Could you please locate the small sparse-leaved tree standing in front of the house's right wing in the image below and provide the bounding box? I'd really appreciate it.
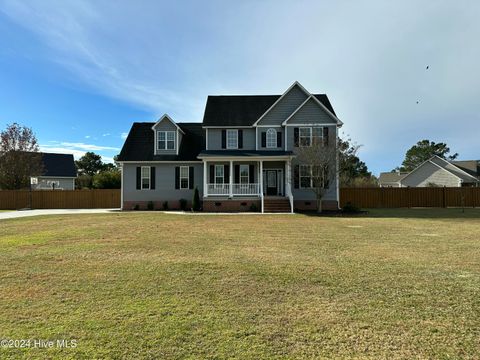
[294,128,338,212]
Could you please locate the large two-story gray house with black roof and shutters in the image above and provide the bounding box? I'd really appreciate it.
[118,82,342,211]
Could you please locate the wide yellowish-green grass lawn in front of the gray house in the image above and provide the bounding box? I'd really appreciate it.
[0,210,480,359]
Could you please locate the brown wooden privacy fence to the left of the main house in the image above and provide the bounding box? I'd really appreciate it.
[0,189,120,210]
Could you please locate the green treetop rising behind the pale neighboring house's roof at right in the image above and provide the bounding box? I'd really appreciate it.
[397,140,458,172]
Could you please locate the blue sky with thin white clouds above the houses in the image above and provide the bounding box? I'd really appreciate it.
[0,0,480,174]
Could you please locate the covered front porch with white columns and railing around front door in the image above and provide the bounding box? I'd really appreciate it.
[197,151,293,212]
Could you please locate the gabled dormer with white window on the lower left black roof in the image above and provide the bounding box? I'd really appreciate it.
[152,114,185,155]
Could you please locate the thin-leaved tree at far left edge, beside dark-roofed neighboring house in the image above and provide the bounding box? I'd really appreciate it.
[0,123,43,190]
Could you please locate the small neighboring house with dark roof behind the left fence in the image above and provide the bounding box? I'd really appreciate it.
[32,153,77,190]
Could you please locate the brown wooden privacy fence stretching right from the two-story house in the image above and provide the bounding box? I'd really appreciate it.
[340,187,480,208]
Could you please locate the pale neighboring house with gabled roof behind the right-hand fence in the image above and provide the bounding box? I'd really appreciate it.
[379,156,480,187]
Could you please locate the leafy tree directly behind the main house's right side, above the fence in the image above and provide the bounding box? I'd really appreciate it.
[338,138,376,186]
